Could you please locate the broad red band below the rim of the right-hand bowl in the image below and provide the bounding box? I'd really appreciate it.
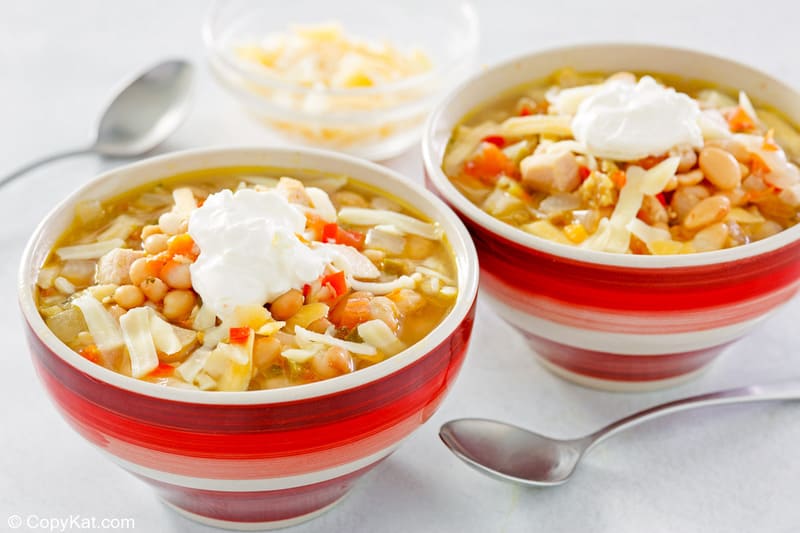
[462,215,800,312]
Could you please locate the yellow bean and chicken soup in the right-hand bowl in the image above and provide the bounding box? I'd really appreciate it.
[442,69,800,254]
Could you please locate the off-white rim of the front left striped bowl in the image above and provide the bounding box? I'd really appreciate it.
[17,146,479,405]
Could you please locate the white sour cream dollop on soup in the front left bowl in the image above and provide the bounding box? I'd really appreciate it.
[189,189,328,319]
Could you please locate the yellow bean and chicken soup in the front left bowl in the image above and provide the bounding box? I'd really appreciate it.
[37,167,456,390]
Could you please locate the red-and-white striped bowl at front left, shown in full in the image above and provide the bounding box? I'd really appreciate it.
[19,148,478,529]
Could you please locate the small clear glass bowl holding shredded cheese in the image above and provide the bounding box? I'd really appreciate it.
[203,0,478,160]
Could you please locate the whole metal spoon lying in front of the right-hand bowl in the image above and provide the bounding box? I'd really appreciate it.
[439,380,800,487]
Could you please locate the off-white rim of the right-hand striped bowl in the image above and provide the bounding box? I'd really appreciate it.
[422,41,800,270]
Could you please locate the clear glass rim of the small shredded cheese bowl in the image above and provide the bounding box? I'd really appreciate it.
[202,0,480,97]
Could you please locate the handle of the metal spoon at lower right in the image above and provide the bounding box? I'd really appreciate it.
[586,379,800,451]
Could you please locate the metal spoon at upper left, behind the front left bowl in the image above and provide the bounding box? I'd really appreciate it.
[0,60,193,187]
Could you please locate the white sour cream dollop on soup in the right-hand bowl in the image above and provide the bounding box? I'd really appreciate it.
[572,76,703,161]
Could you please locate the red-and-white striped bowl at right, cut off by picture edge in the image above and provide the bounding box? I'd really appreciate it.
[423,44,800,390]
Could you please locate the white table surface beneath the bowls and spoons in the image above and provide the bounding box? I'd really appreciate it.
[0,0,800,533]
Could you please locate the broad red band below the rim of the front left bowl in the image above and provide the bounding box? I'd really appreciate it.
[28,303,475,479]
